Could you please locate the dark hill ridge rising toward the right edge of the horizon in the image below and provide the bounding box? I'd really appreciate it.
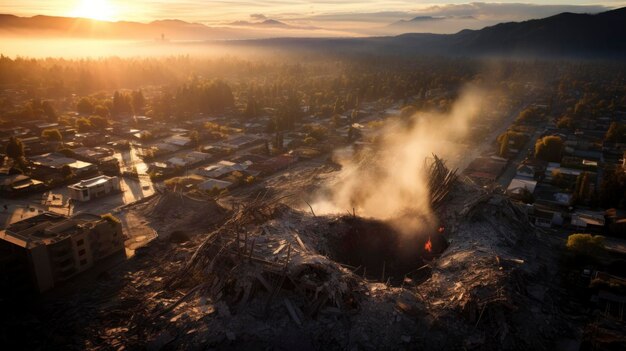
[235,8,626,58]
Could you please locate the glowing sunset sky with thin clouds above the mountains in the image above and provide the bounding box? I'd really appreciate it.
[0,0,626,34]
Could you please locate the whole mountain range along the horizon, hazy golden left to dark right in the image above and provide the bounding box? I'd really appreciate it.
[0,7,626,57]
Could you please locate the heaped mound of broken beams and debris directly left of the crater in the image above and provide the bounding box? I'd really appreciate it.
[168,195,366,338]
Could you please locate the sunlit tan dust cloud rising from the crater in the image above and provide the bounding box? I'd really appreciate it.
[312,86,487,234]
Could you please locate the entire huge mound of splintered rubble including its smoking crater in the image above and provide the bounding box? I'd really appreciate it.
[1,157,596,350]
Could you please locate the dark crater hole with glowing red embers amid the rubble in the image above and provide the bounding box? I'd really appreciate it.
[328,216,448,285]
